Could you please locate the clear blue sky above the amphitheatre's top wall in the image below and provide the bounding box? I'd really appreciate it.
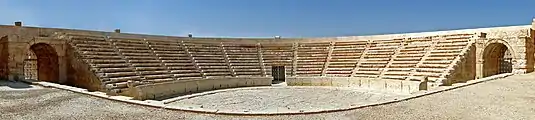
[0,0,535,37]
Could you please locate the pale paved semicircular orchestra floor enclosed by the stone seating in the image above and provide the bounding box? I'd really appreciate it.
[167,86,408,113]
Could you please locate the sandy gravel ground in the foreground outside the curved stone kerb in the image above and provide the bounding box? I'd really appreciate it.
[0,73,535,120]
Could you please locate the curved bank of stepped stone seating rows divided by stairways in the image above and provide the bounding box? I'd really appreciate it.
[65,34,475,99]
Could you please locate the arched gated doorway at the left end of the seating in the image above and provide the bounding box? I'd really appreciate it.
[24,43,59,83]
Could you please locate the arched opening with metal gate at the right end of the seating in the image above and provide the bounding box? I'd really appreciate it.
[483,43,513,77]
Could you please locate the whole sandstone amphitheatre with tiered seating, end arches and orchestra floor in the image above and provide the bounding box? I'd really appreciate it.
[0,19,535,118]
